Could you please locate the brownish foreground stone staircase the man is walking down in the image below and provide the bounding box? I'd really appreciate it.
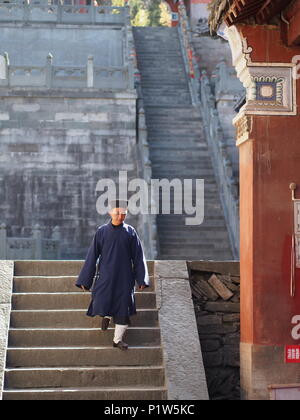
[3,261,167,400]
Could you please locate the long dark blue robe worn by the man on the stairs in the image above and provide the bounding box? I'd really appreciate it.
[76,221,149,323]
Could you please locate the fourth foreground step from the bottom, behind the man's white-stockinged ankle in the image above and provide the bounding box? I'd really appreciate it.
[8,327,160,351]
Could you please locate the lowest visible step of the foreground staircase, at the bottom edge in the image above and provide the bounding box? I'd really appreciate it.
[3,386,167,401]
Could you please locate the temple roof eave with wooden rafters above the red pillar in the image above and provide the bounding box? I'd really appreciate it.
[208,0,292,32]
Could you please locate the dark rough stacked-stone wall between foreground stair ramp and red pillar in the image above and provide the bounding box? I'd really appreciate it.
[188,261,240,400]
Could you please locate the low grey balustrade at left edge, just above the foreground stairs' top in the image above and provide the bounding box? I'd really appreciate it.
[0,223,61,260]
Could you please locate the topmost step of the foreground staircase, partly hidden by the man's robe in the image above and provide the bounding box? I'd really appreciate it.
[14,260,154,276]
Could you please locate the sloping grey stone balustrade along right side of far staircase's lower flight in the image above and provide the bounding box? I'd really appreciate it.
[201,71,240,259]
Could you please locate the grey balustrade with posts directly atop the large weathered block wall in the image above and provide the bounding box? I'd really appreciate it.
[0,53,133,90]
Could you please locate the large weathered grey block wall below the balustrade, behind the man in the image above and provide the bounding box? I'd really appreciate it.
[0,88,138,259]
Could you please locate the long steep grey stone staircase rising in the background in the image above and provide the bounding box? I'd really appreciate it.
[133,27,232,260]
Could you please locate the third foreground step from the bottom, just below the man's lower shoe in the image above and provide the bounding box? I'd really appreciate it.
[7,344,163,367]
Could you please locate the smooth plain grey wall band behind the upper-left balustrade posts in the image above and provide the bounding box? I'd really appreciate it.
[1,23,125,67]
